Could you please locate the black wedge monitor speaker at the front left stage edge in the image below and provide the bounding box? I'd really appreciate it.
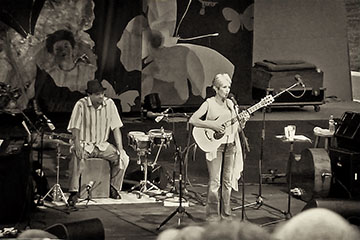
[45,218,105,240]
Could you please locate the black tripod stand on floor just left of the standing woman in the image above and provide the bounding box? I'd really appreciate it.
[156,136,194,230]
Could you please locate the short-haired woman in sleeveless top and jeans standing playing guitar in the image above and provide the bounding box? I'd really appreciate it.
[189,73,250,221]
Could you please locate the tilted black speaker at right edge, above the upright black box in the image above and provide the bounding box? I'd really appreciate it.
[334,112,360,151]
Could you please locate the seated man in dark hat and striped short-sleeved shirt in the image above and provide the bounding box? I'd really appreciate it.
[68,80,129,206]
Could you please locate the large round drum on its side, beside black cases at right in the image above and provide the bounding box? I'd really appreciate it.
[290,148,332,201]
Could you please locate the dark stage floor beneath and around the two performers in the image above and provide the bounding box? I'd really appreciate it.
[2,101,360,239]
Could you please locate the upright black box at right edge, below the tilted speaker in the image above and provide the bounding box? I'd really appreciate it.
[329,148,360,199]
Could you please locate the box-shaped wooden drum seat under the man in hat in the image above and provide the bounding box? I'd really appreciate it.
[80,158,110,198]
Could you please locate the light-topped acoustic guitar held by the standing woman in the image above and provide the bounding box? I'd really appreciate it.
[192,95,274,152]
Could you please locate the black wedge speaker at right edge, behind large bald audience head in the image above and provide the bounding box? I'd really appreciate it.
[301,198,360,225]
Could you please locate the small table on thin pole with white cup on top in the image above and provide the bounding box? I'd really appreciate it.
[276,135,311,217]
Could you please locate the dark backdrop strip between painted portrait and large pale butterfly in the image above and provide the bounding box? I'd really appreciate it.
[88,0,142,99]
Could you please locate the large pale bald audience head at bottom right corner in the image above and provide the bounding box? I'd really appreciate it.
[272,208,360,240]
